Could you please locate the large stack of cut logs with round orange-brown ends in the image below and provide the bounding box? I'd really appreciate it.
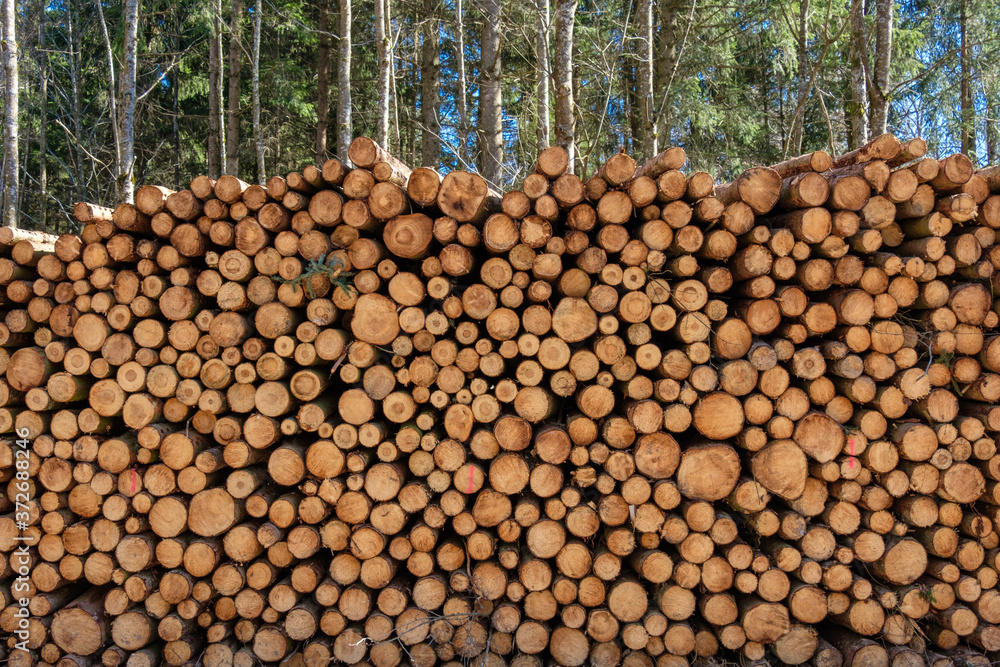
[0,135,1000,667]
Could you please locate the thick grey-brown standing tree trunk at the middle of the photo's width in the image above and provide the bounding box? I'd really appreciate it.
[478,0,503,187]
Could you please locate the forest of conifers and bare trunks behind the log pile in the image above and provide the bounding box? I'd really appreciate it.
[0,0,1000,232]
